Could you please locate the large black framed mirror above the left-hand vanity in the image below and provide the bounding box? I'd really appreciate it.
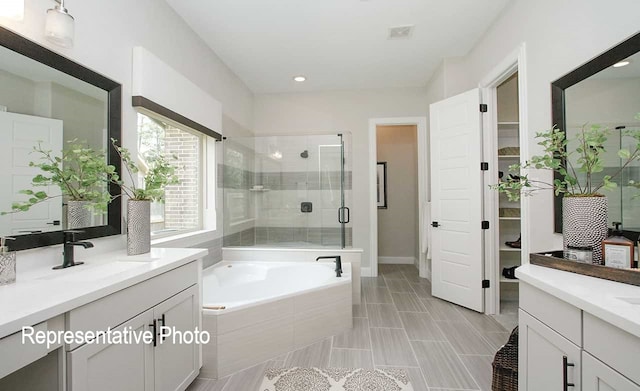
[0,27,122,250]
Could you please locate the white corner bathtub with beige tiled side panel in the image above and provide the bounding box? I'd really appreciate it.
[200,261,353,379]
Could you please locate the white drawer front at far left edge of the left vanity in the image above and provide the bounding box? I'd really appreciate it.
[0,315,64,379]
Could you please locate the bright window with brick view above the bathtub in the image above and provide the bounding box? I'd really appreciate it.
[138,113,215,235]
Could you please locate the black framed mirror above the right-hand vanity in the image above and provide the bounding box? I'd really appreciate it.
[551,33,640,233]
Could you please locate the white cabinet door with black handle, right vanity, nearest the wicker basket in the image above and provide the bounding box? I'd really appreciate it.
[518,310,580,391]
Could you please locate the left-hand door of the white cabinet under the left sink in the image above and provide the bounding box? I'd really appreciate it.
[67,310,154,391]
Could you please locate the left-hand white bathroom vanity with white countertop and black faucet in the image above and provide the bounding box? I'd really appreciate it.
[0,249,207,391]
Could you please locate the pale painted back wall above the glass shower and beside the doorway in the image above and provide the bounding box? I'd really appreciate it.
[254,88,428,268]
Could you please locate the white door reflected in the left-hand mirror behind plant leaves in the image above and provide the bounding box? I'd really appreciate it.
[0,112,62,236]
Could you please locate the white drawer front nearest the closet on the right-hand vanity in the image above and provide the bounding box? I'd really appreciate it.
[520,283,582,346]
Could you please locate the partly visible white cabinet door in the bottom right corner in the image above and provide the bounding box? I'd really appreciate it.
[582,352,640,391]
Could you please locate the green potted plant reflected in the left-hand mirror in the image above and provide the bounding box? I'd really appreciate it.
[3,139,118,228]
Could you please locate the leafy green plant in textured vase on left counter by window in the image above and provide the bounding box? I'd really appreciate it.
[111,139,179,255]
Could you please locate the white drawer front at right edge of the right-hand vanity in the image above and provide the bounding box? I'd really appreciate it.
[584,312,640,384]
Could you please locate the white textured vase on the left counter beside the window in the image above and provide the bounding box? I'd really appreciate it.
[127,200,151,255]
